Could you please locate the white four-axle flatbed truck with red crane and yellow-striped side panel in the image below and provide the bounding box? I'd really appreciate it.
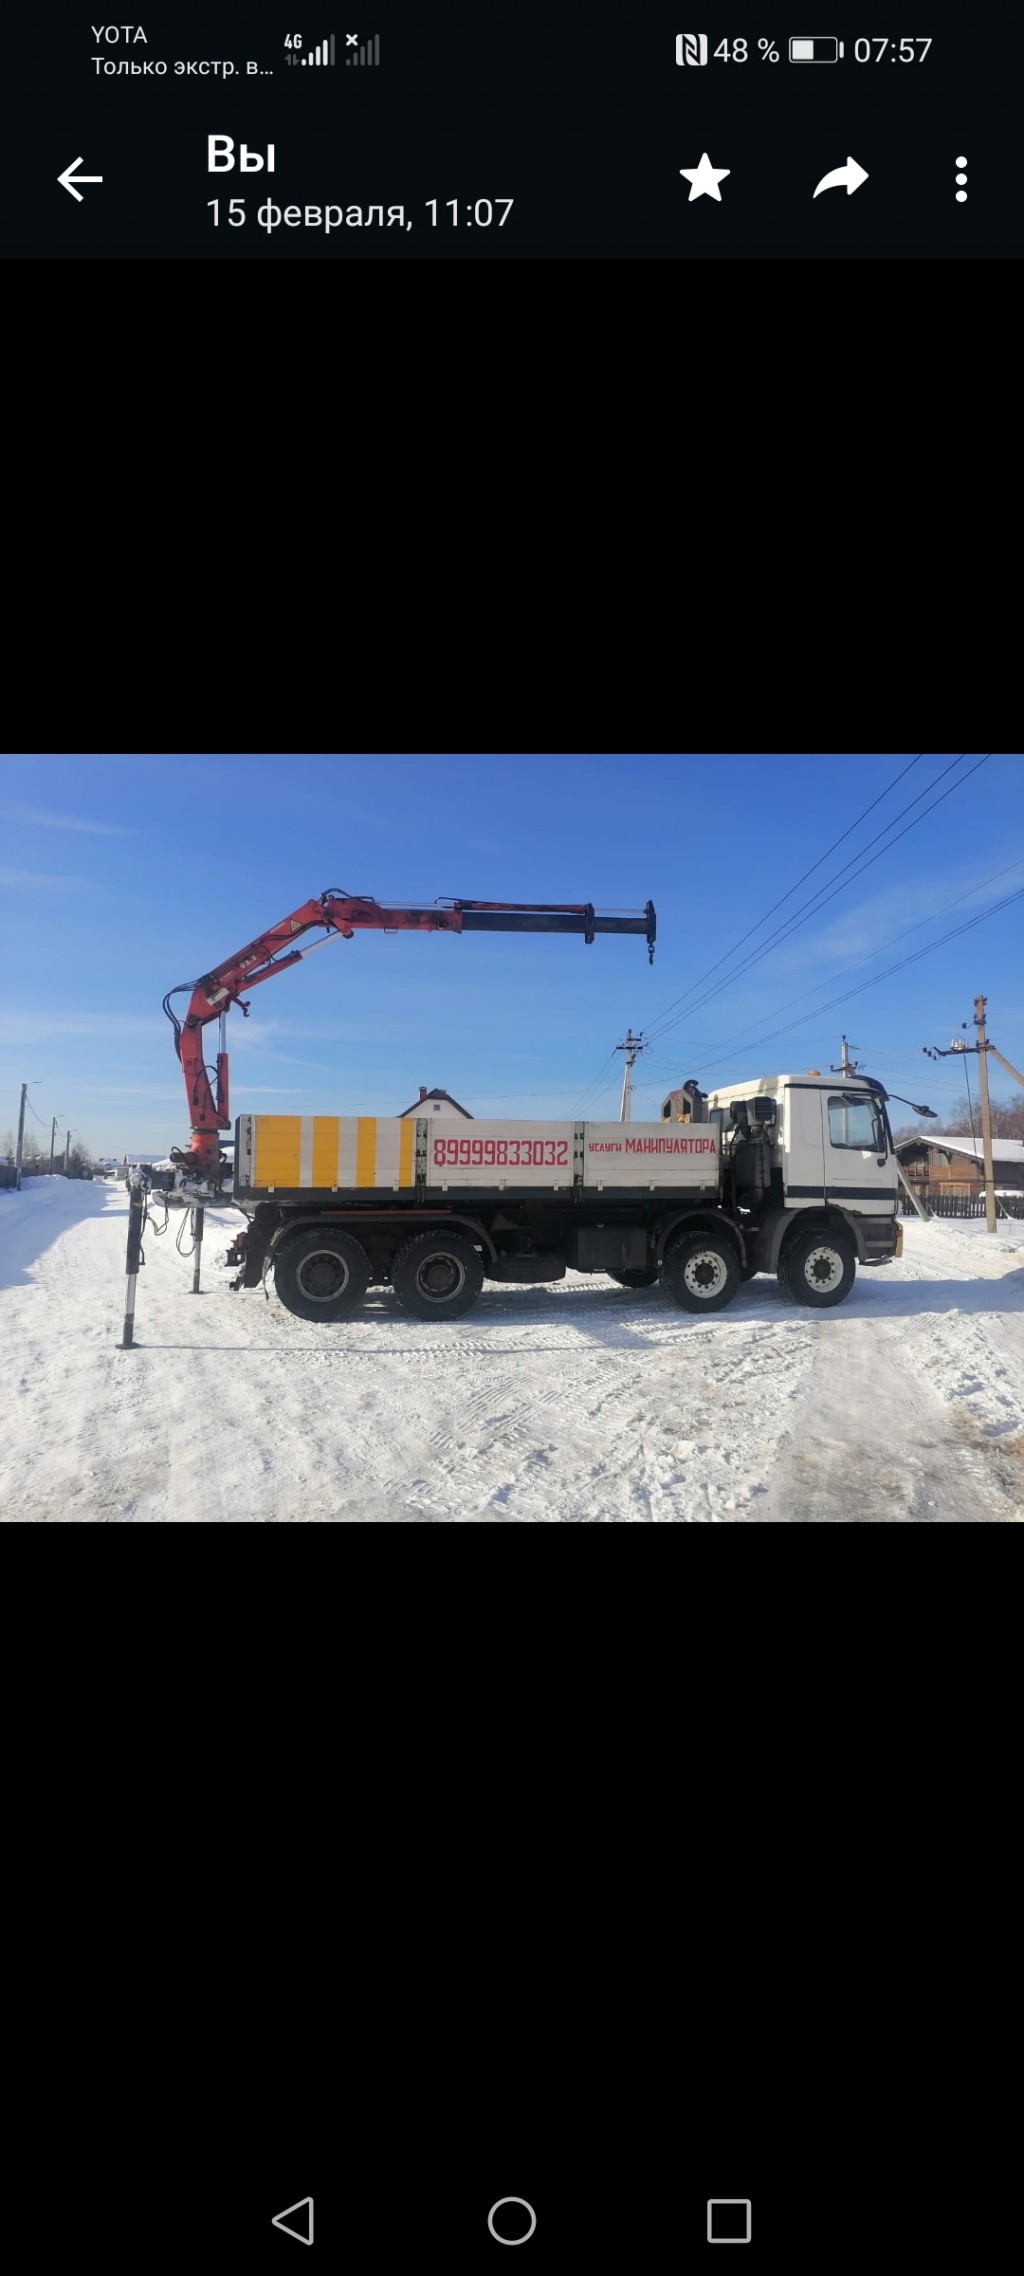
[146,890,903,1322]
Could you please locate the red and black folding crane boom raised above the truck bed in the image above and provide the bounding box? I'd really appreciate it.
[164,888,655,1188]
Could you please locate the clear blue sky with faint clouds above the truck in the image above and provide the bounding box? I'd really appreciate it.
[0,753,1024,1154]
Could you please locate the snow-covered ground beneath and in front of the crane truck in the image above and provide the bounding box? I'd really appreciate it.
[0,1177,1024,1525]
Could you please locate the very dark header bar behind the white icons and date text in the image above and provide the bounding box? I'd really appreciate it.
[5,0,1024,259]
